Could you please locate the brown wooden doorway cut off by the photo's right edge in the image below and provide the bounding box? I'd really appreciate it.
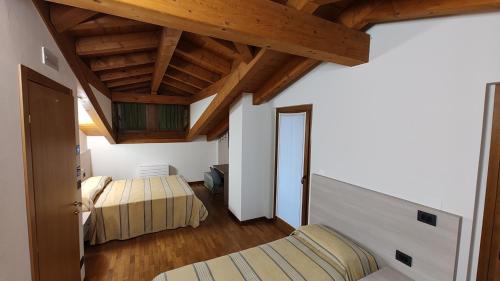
[477,85,500,281]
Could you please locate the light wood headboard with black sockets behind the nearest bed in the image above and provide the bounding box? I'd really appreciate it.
[310,175,461,281]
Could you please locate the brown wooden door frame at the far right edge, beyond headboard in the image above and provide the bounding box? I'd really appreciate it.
[477,85,500,281]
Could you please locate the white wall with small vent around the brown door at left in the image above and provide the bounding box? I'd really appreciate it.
[0,0,82,281]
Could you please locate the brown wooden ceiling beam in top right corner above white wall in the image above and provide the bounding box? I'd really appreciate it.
[338,0,500,29]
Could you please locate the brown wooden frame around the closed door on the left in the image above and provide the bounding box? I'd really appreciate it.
[19,65,73,281]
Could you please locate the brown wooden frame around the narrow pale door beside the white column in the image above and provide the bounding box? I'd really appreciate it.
[273,104,313,232]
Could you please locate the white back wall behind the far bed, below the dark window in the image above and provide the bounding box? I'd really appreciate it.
[87,136,217,181]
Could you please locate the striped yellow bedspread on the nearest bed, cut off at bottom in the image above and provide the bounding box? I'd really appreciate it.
[153,225,378,281]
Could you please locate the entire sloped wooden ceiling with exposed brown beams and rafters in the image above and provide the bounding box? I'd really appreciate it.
[37,0,500,141]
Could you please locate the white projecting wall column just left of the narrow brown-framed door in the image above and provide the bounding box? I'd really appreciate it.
[228,94,274,221]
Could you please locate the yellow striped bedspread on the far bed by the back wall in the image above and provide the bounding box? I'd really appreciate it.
[90,175,208,245]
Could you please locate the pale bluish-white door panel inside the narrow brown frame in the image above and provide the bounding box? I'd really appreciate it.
[276,112,307,228]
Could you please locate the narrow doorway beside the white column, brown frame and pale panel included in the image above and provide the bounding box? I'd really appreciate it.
[274,105,312,232]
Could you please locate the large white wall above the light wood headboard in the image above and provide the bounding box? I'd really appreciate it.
[273,13,500,280]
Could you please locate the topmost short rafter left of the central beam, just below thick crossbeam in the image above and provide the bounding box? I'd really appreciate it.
[76,31,160,56]
